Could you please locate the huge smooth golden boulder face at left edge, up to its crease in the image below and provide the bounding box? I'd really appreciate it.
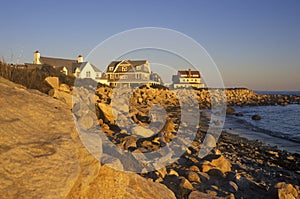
[0,78,80,198]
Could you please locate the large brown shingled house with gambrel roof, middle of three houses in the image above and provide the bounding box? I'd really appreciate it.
[104,60,161,87]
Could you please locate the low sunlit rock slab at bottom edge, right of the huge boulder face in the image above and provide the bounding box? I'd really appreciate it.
[69,165,175,199]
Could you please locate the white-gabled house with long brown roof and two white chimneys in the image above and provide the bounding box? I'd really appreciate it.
[25,51,102,81]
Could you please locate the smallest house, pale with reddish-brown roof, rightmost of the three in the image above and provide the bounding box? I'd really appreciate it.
[172,69,204,88]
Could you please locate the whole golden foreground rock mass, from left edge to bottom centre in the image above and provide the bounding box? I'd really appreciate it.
[0,77,175,199]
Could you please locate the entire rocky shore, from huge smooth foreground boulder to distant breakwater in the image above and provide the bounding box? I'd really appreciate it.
[0,78,300,199]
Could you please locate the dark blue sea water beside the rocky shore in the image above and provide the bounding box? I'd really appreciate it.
[224,92,300,153]
